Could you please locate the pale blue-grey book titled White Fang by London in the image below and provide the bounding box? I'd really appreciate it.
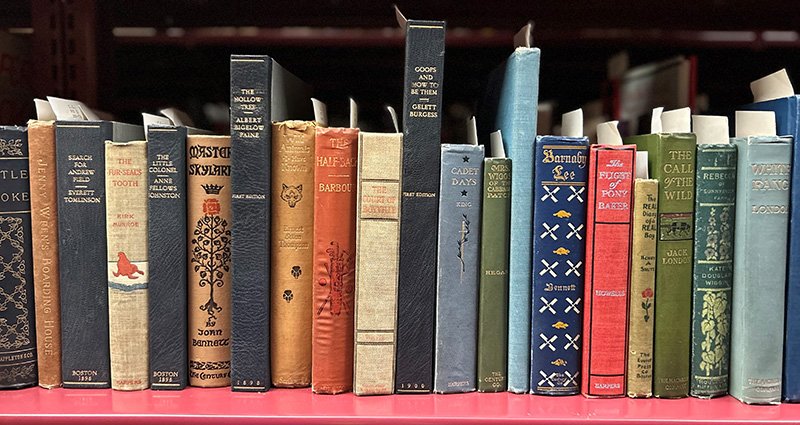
[729,137,792,404]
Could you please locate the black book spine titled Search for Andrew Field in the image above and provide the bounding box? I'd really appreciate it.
[56,121,112,388]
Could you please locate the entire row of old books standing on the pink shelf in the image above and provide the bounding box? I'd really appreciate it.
[0,14,800,403]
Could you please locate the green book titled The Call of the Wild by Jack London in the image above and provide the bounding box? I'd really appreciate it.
[625,133,696,398]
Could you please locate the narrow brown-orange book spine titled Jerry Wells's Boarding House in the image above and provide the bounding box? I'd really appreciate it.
[28,121,61,388]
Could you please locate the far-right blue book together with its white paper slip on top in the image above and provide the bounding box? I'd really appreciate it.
[743,69,800,402]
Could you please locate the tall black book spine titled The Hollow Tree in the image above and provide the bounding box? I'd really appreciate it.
[230,55,272,391]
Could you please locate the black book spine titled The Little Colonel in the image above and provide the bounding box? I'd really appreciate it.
[147,127,189,390]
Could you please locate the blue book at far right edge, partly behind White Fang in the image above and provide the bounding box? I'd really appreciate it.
[741,95,800,402]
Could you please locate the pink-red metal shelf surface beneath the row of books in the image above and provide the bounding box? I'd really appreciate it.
[0,388,800,425]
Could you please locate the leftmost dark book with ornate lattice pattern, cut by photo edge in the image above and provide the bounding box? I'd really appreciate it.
[0,126,38,388]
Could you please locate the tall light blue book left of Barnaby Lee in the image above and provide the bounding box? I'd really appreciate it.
[497,48,541,393]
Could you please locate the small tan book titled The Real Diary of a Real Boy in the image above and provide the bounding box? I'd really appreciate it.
[626,179,658,398]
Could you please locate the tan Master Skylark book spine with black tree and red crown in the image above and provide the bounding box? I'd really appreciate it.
[186,135,231,387]
